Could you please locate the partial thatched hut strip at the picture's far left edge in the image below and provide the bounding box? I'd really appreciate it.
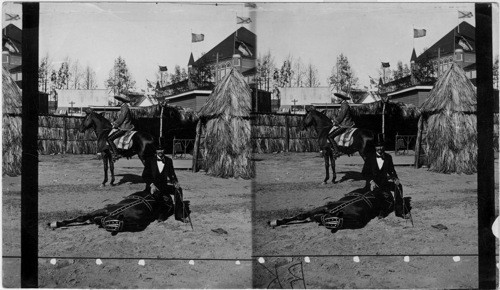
[2,68,22,176]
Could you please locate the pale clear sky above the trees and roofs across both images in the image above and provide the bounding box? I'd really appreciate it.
[3,2,498,89]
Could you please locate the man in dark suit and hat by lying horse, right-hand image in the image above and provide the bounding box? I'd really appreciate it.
[362,134,406,218]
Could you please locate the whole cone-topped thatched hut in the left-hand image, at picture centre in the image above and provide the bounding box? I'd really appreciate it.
[199,69,255,179]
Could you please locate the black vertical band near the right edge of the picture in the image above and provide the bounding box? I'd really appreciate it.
[476,3,496,289]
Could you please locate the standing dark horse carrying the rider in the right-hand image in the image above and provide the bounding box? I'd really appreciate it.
[302,107,375,184]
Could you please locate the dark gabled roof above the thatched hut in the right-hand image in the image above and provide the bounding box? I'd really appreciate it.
[417,21,476,62]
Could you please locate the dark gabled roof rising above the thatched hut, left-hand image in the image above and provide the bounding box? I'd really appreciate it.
[194,27,256,65]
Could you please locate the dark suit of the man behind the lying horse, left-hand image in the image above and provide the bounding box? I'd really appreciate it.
[142,155,185,219]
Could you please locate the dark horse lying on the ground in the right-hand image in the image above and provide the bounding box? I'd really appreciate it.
[267,188,411,233]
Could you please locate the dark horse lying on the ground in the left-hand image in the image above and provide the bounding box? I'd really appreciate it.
[48,189,191,236]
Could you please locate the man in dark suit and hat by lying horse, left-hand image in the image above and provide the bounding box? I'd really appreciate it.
[142,150,189,222]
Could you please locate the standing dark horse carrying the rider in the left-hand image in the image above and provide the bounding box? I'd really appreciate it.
[80,110,156,186]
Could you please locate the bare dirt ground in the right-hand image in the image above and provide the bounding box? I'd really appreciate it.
[252,153,498,289]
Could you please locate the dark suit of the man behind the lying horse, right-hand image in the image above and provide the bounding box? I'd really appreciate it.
[362,152,403,217]
